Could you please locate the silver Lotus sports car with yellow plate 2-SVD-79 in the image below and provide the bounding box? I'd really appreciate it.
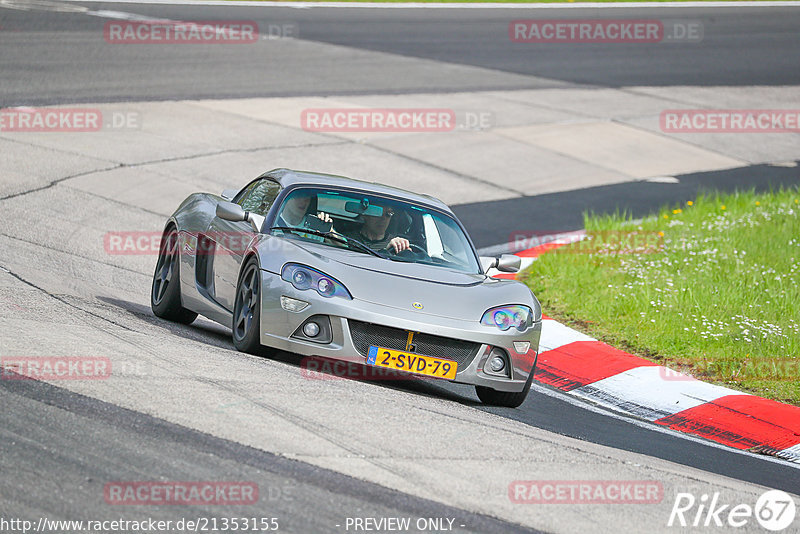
[151,169,542,407]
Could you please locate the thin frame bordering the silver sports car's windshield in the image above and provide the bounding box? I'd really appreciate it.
[261,183,486,275]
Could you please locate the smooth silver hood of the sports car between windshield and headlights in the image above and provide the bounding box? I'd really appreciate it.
[253,237,541,321]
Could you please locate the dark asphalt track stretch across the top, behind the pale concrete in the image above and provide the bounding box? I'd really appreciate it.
[0,0,800,106]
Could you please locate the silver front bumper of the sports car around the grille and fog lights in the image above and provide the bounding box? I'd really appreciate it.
[260,270,542,392]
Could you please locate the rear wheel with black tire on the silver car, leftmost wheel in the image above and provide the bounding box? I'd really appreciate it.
[150,226,197,324]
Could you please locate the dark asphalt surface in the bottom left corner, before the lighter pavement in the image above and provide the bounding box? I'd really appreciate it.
[0,374,532,532]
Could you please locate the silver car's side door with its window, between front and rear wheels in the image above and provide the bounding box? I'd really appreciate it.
[206,178,281,312]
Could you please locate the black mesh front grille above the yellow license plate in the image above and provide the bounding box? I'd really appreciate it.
[348,320,481,369]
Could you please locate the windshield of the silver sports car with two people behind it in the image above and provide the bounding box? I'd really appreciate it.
[270,188,481,273]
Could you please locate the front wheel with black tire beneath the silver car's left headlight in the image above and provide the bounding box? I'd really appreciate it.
[231,256,263,354]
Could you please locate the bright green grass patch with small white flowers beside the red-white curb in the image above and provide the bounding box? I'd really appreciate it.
[520,188,800,405]
